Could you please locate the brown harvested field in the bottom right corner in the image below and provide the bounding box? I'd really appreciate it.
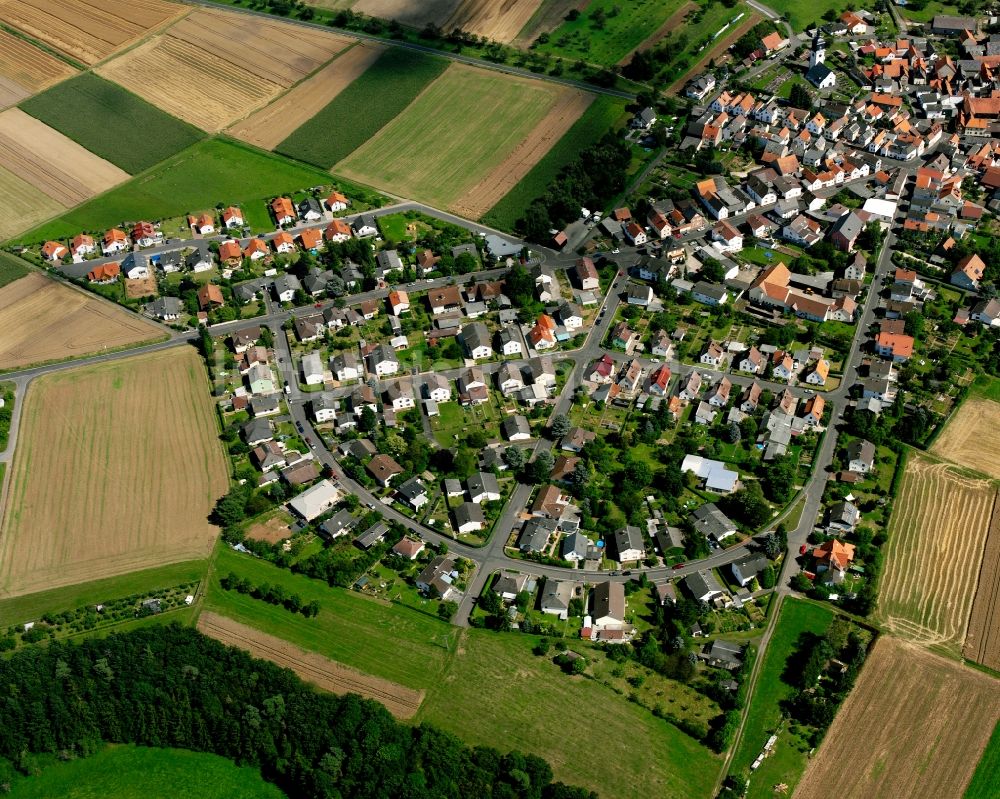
[795,636,1000,799]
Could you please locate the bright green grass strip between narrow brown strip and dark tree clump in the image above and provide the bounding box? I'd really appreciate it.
[483,95,625,230]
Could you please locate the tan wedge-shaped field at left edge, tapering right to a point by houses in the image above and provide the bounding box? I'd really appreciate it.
[0,272,164,369]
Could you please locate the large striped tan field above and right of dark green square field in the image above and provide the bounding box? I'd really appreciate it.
[97,10,353,133]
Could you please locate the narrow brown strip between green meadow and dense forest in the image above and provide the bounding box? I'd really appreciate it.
[198,610,424,719]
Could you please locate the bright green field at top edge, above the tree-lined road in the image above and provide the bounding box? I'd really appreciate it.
[537,0,684,67]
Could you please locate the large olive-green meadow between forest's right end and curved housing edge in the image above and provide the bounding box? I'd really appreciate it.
[416,630,720,799]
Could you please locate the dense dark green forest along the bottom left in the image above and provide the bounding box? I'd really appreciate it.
[0,624,596,799]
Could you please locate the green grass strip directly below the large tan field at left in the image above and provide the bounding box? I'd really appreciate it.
[0,560,208,629]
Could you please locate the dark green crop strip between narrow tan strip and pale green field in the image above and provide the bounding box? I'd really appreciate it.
[275,47,448,169]
